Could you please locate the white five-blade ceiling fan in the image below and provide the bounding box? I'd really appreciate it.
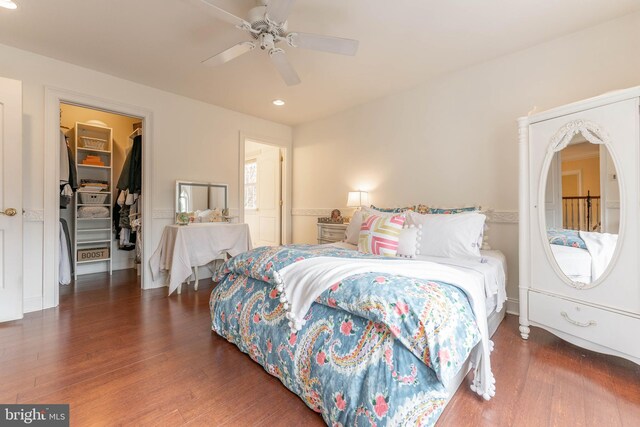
[189,0,359,86]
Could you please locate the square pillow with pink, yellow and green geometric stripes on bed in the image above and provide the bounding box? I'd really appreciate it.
[358,213,406,256]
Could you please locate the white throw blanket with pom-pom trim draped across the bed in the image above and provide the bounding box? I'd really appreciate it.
[274,257,495,400]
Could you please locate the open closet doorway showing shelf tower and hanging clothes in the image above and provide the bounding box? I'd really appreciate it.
[54,102,144,292]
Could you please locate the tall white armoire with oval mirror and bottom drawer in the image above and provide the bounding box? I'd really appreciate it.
[518,87,640,364]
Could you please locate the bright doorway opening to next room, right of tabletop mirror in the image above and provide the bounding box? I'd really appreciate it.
[242,138,285,247]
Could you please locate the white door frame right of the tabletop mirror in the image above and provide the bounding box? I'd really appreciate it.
[238,132,293,245]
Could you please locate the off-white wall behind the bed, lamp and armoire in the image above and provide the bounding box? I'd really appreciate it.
[293,14,640,310]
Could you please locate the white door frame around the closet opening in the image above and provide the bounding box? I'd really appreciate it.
[42,86,153,309]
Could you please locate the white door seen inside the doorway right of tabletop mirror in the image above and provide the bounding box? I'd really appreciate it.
[254,147,281,246]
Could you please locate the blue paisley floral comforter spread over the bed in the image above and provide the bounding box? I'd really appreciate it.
[210,245,480,426]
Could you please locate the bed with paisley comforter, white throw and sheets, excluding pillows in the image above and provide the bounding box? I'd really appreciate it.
[210,236,506,426]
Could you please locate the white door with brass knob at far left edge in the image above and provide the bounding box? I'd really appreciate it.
[0,77,22,322]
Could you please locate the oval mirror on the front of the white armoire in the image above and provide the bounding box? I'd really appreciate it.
[543,129,620,288]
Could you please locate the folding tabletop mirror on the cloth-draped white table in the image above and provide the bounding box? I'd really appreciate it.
[176,181,228,213]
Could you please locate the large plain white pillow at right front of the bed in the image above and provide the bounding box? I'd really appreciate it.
[409,212,486,258]
